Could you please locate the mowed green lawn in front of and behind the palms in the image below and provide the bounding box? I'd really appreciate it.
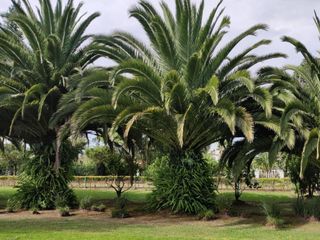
[0,188,320,240]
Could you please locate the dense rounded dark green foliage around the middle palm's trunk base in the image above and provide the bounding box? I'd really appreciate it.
[149,155,215,214]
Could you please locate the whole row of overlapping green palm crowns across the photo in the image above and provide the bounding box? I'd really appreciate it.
[0,0,320,212]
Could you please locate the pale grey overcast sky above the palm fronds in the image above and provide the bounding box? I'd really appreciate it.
[0,0,320,70]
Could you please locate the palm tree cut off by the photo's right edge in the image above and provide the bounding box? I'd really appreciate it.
[274,13,320,177]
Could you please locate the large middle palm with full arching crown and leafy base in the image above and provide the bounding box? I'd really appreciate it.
[61,0,283,213]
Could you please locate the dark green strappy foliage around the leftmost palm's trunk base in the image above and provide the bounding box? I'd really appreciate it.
[12,141,79,209]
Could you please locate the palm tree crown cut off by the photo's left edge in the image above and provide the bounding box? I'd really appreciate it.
[0,0,99,208]
